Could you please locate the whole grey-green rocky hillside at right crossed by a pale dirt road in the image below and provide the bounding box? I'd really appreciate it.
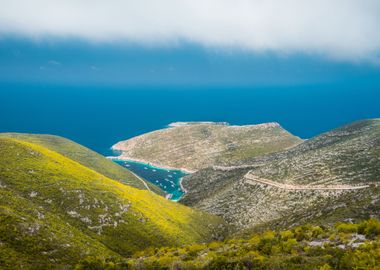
[181,119,380,231]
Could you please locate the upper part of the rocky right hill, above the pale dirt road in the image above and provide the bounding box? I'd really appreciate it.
[243,119,380,185]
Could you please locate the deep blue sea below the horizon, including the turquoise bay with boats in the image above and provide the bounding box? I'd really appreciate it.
[0,83,380,200]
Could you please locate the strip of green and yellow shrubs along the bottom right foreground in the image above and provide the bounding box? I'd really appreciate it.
[77,219,380,270]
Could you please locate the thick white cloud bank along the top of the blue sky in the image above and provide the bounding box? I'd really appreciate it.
[0,0,380,61]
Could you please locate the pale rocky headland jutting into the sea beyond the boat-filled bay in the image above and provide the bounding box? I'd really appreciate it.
[112,122,302,171]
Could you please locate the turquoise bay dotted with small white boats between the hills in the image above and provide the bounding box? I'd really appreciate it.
[114,159,187,201]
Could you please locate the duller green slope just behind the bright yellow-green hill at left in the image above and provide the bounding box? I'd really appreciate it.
[0,133,165,196]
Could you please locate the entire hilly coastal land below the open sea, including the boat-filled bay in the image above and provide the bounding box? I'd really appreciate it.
[0,119,380,269]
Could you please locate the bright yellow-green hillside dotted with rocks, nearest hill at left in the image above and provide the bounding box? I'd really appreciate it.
[0,138,224,269]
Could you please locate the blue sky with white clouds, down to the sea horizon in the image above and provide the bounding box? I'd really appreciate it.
[0,0,380,85]
